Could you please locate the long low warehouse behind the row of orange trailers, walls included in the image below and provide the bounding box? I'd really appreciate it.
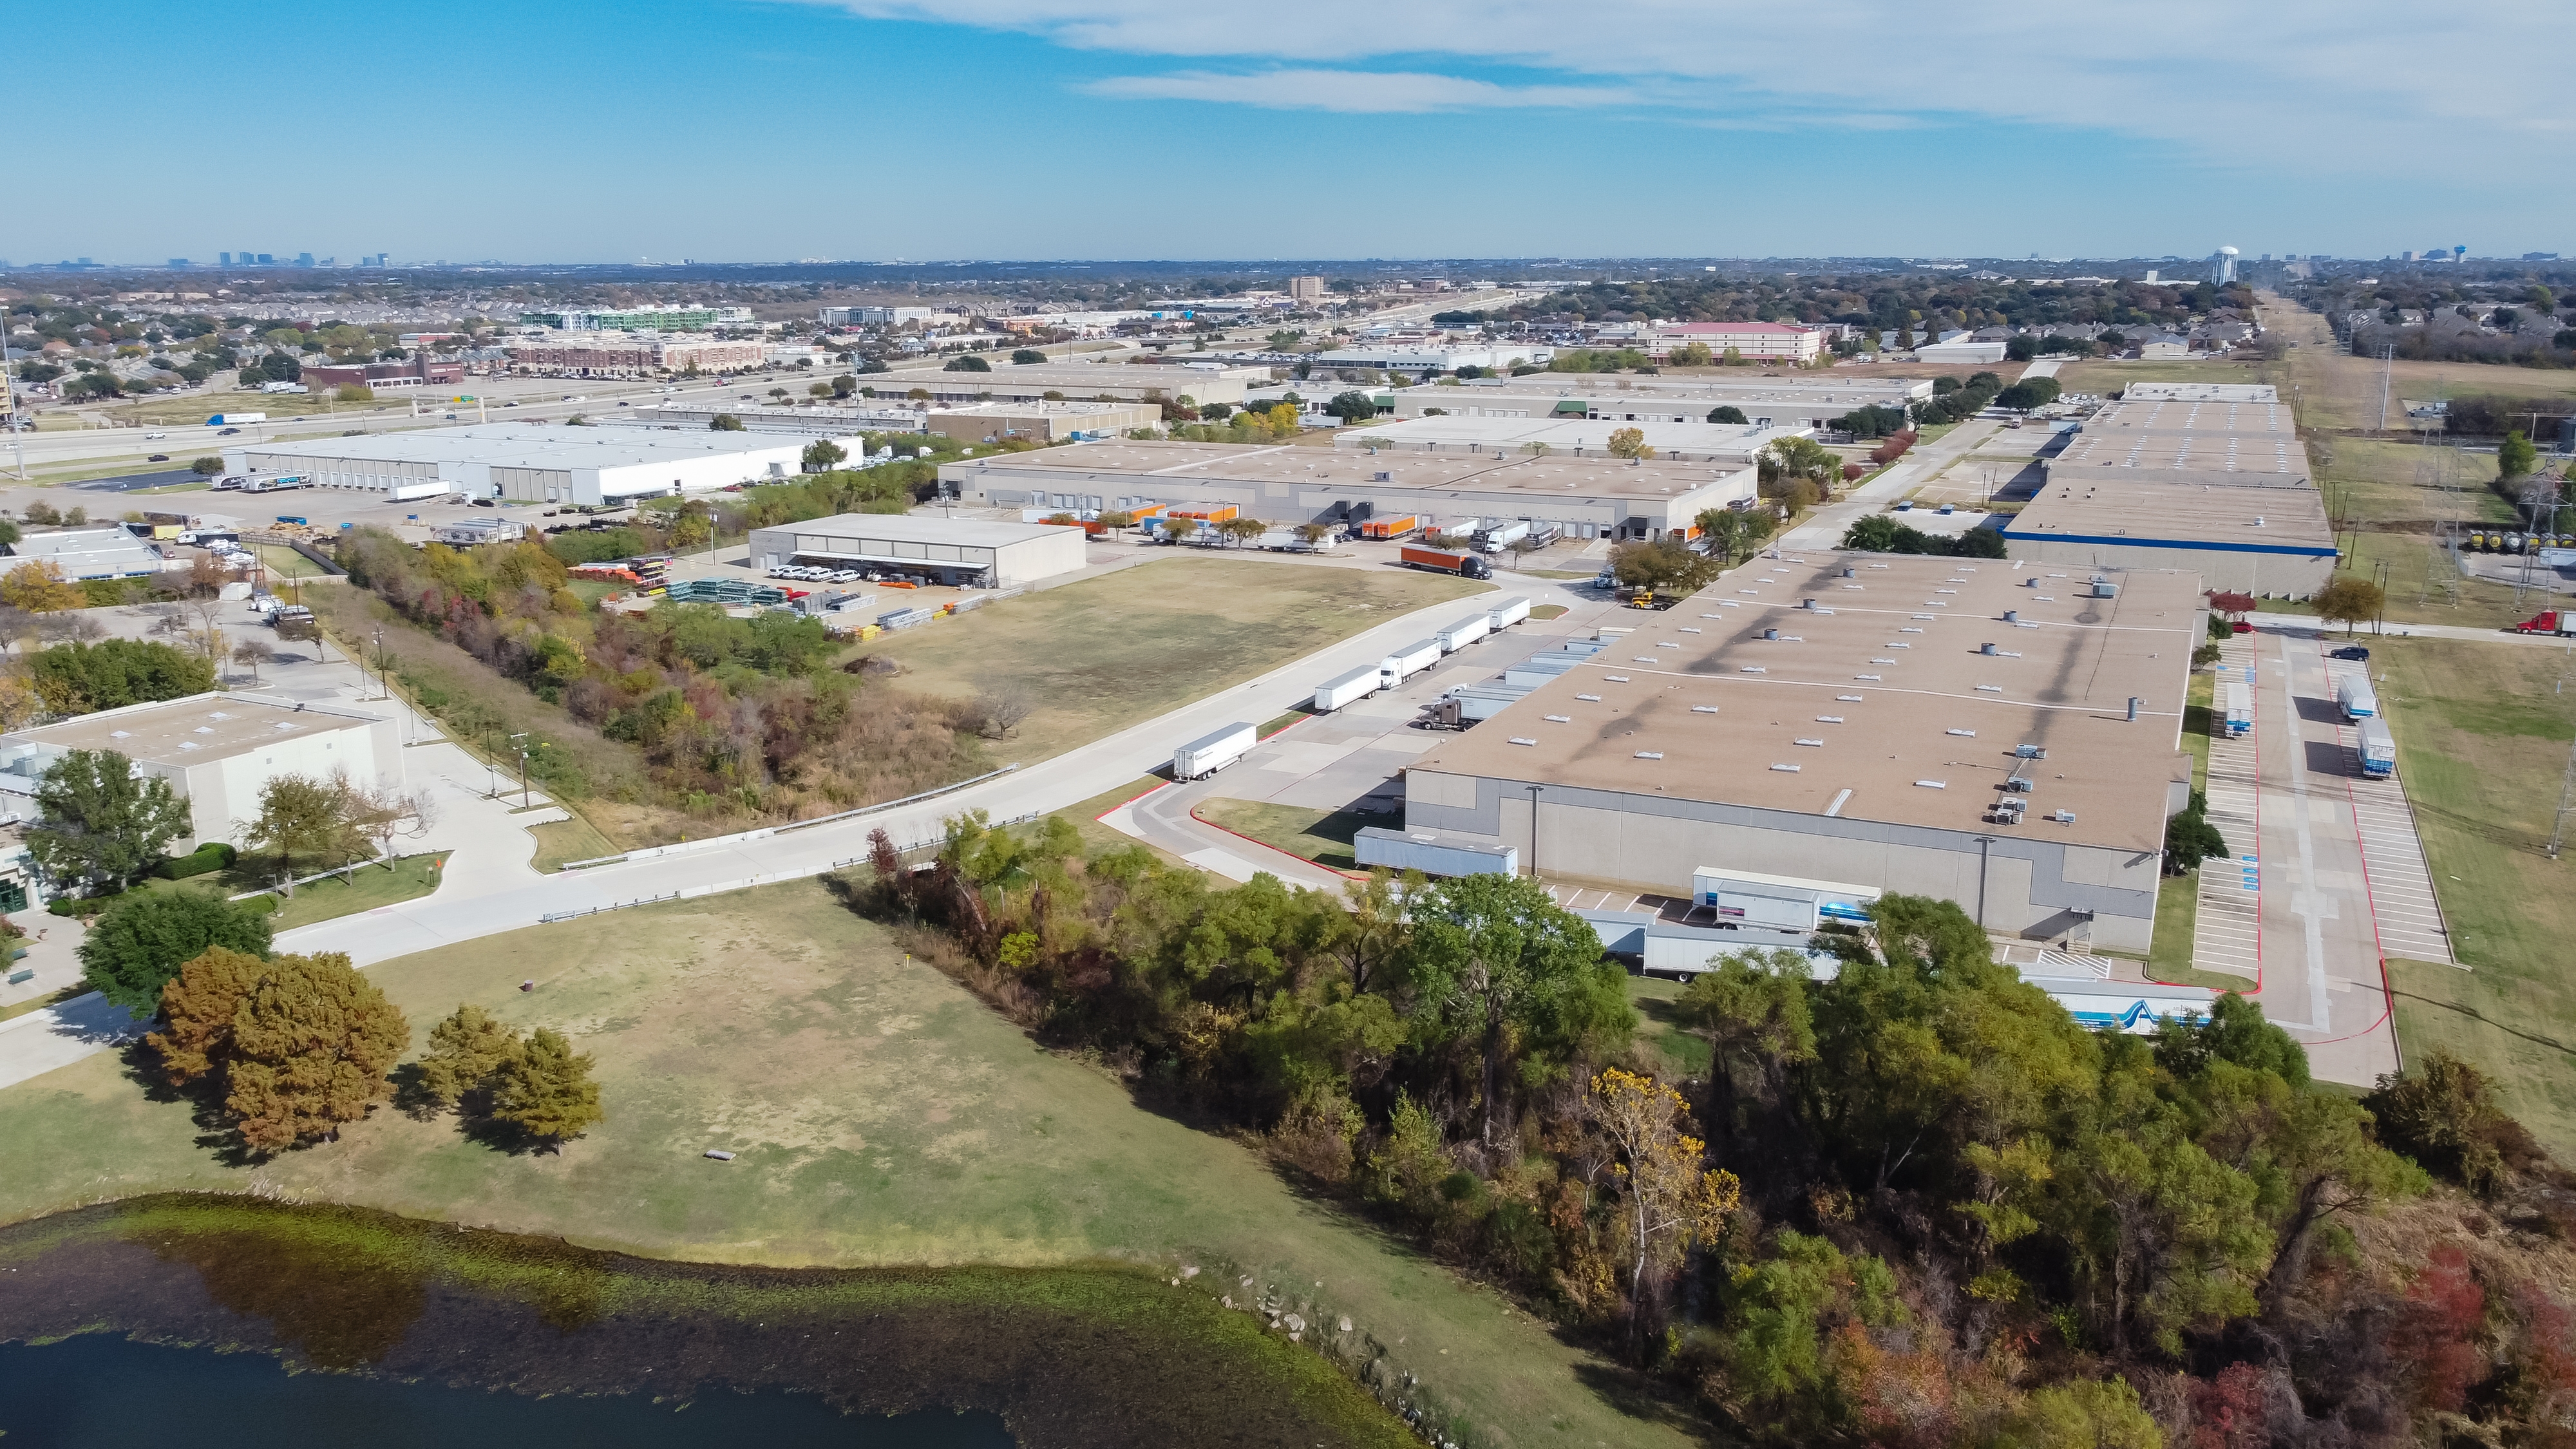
[940,444,1754,539]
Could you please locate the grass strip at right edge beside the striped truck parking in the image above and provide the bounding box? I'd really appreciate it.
[2372,639,2576,1160]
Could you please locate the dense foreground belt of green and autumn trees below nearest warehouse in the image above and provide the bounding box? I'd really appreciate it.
[845,815,2576,1449]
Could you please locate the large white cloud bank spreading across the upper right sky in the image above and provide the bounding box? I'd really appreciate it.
[804,0,2576,175]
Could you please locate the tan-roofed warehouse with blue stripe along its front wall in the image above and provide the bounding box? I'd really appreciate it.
[2002,382,2336,598]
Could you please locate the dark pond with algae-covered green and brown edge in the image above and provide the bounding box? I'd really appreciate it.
[0,1197,1417,1449]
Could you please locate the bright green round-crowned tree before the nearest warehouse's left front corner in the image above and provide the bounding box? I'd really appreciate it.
[1409,874,1602,1148]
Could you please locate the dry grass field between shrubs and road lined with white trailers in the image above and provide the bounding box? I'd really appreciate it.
[853,557,1489,761]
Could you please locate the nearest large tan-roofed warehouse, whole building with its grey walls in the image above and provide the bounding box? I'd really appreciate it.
[1404,552,2202,951]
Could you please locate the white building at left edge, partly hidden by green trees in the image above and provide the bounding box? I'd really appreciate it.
[0,691,402,851]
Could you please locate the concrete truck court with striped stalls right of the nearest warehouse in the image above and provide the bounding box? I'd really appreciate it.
[2192,621,2455,1085]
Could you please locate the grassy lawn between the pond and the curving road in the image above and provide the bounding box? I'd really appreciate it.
[0,884,1695,1449]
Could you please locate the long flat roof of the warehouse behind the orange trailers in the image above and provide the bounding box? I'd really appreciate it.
[940,444,1741,500]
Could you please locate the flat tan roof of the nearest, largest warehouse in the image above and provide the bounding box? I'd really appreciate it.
[1414,552,2202,851]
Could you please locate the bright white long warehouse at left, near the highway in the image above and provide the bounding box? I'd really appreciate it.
[224,423,863,506]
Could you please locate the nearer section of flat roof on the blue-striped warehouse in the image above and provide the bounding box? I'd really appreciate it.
[2004,469,2336,554]
